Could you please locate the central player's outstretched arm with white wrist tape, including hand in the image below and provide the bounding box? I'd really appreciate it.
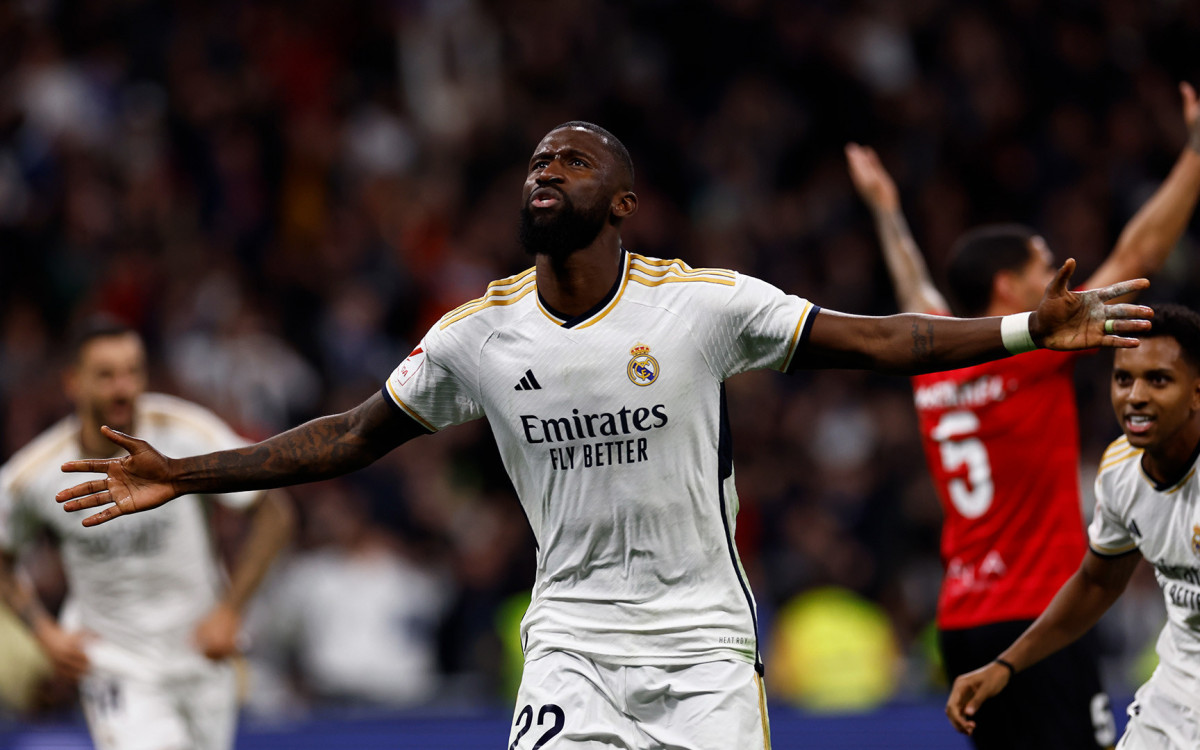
[797,259,1153,374]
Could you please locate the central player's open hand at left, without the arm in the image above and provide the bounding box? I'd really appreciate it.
[54,426,179,526]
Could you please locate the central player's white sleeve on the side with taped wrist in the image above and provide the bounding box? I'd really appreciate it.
[707,274,820,379]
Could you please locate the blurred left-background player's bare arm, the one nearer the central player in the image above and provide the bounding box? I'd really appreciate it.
[196,490,295,659]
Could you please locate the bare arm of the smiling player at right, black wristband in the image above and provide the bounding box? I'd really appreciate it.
[946,551,1141,734]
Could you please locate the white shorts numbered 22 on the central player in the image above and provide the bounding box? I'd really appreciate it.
[508,652,770,750]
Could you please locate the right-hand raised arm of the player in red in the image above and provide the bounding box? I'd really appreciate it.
[1085,83,1200,289]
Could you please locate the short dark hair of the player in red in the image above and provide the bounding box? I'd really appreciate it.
[946,224,1038,318]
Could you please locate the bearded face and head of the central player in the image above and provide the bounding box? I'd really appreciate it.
[521,127,617,257]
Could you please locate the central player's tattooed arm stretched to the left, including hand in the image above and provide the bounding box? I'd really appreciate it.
[55,394,426,526]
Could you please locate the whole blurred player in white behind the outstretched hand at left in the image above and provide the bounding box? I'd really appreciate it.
[0,322,292,750]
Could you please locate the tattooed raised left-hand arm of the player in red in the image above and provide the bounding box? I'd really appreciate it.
[846,143,950,314]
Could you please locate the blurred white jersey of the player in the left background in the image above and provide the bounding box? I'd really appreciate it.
[0,394,259,677]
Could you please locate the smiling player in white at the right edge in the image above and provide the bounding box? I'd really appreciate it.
[946,305,1200,750]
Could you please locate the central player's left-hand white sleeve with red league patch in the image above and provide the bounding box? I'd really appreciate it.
[383,325,484,432]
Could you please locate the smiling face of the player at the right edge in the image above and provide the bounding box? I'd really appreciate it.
[1111,336,1200,455]
